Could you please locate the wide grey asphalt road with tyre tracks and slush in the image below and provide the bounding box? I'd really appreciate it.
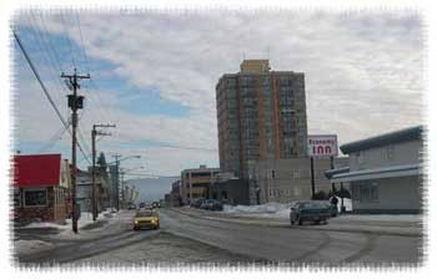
[17,209,422,266]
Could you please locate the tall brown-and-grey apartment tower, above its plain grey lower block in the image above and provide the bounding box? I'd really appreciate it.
[216,60,308,180]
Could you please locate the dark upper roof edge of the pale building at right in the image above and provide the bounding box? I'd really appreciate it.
[340,126,423,154]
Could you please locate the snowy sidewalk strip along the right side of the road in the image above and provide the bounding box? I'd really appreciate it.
[172,207,424,237]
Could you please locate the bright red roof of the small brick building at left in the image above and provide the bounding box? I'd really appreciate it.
[14,154,61,187]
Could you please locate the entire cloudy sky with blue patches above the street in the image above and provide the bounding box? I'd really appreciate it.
[13,10,424,175]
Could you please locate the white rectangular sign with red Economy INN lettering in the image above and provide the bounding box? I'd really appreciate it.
[308,135,338,157]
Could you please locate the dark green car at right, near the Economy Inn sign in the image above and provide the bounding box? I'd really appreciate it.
[290,201,331,225]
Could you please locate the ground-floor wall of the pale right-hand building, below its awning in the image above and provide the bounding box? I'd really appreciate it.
[351,176,422,213]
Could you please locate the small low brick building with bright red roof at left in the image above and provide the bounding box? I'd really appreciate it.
[13,154,71,222]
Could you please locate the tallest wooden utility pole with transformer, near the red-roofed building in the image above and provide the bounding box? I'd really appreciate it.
[61,68,90,233]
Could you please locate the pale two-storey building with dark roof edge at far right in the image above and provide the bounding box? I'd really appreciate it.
[330,126,423,213]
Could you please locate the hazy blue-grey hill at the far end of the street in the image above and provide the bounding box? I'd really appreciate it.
[127,176,180,202]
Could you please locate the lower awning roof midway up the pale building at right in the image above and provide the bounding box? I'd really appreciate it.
[331,164,421,183]
